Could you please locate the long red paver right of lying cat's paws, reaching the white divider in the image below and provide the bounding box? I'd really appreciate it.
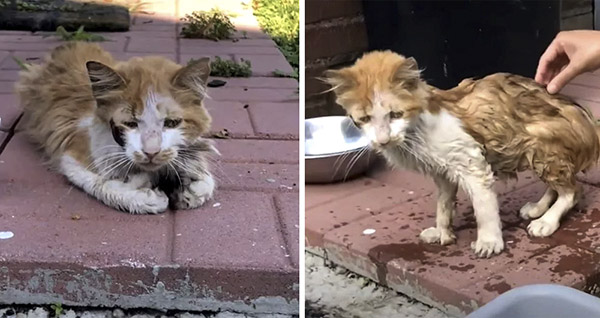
[215,162,300,192]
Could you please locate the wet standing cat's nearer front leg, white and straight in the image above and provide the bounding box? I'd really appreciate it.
[461,169,504,257]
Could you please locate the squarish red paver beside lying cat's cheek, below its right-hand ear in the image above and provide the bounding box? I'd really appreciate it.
[204,100,254,138]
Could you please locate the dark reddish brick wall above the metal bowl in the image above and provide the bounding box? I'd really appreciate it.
[305,0,368,118]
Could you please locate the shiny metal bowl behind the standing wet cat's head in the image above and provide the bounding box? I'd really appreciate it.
[304,116,374,183]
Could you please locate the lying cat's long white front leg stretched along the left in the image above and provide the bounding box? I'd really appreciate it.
[60,155,169,214]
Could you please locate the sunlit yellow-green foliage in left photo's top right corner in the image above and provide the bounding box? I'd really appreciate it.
[252,0,300,78]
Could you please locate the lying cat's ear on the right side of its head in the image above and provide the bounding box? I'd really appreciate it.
[171,57,210,98]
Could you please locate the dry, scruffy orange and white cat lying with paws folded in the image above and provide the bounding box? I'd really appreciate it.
[16,43,216,214]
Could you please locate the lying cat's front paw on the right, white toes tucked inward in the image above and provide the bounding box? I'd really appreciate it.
[172,175,215,210]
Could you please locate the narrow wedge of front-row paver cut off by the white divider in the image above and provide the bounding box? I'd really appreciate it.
[275,193,300,267]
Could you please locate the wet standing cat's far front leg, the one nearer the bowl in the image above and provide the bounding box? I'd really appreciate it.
[419,176,458,245]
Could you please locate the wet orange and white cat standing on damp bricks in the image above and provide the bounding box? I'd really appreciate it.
[325,51,600,257]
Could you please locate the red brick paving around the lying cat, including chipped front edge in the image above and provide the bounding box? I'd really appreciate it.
[0,0,299,314]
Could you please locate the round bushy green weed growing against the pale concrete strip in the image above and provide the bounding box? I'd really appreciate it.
[181,8,235,41]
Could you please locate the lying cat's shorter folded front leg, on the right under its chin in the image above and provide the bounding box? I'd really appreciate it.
[171,172,215,210]
